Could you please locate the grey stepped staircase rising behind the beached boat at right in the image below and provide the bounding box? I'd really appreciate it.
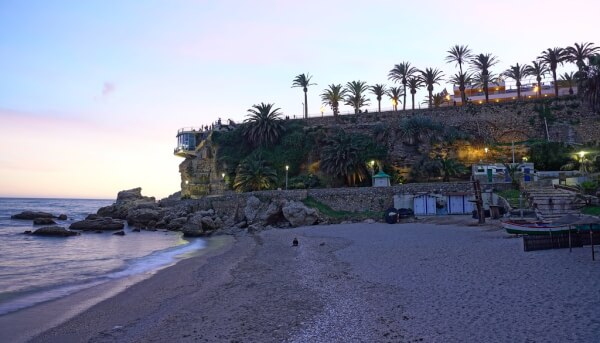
[524,186,585,221]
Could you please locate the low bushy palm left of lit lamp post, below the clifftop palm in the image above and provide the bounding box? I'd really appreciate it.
[233,156,277,192]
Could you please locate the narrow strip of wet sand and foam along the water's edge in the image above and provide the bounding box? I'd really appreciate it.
[0,236,231,342]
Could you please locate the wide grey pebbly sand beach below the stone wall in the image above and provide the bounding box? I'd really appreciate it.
[9,219,600,342]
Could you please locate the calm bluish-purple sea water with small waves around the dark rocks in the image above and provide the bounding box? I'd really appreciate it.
[0,198,205,316]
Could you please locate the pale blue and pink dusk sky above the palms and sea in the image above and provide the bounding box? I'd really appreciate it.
[0,0,600,199]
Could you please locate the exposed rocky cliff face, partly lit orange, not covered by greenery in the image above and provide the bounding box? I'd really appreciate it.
[179,98,600,197]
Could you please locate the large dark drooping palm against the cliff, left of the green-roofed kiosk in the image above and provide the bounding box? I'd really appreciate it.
[319,131,367,186]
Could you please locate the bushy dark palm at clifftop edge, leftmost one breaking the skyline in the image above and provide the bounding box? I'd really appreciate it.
[243,102,285,145]
